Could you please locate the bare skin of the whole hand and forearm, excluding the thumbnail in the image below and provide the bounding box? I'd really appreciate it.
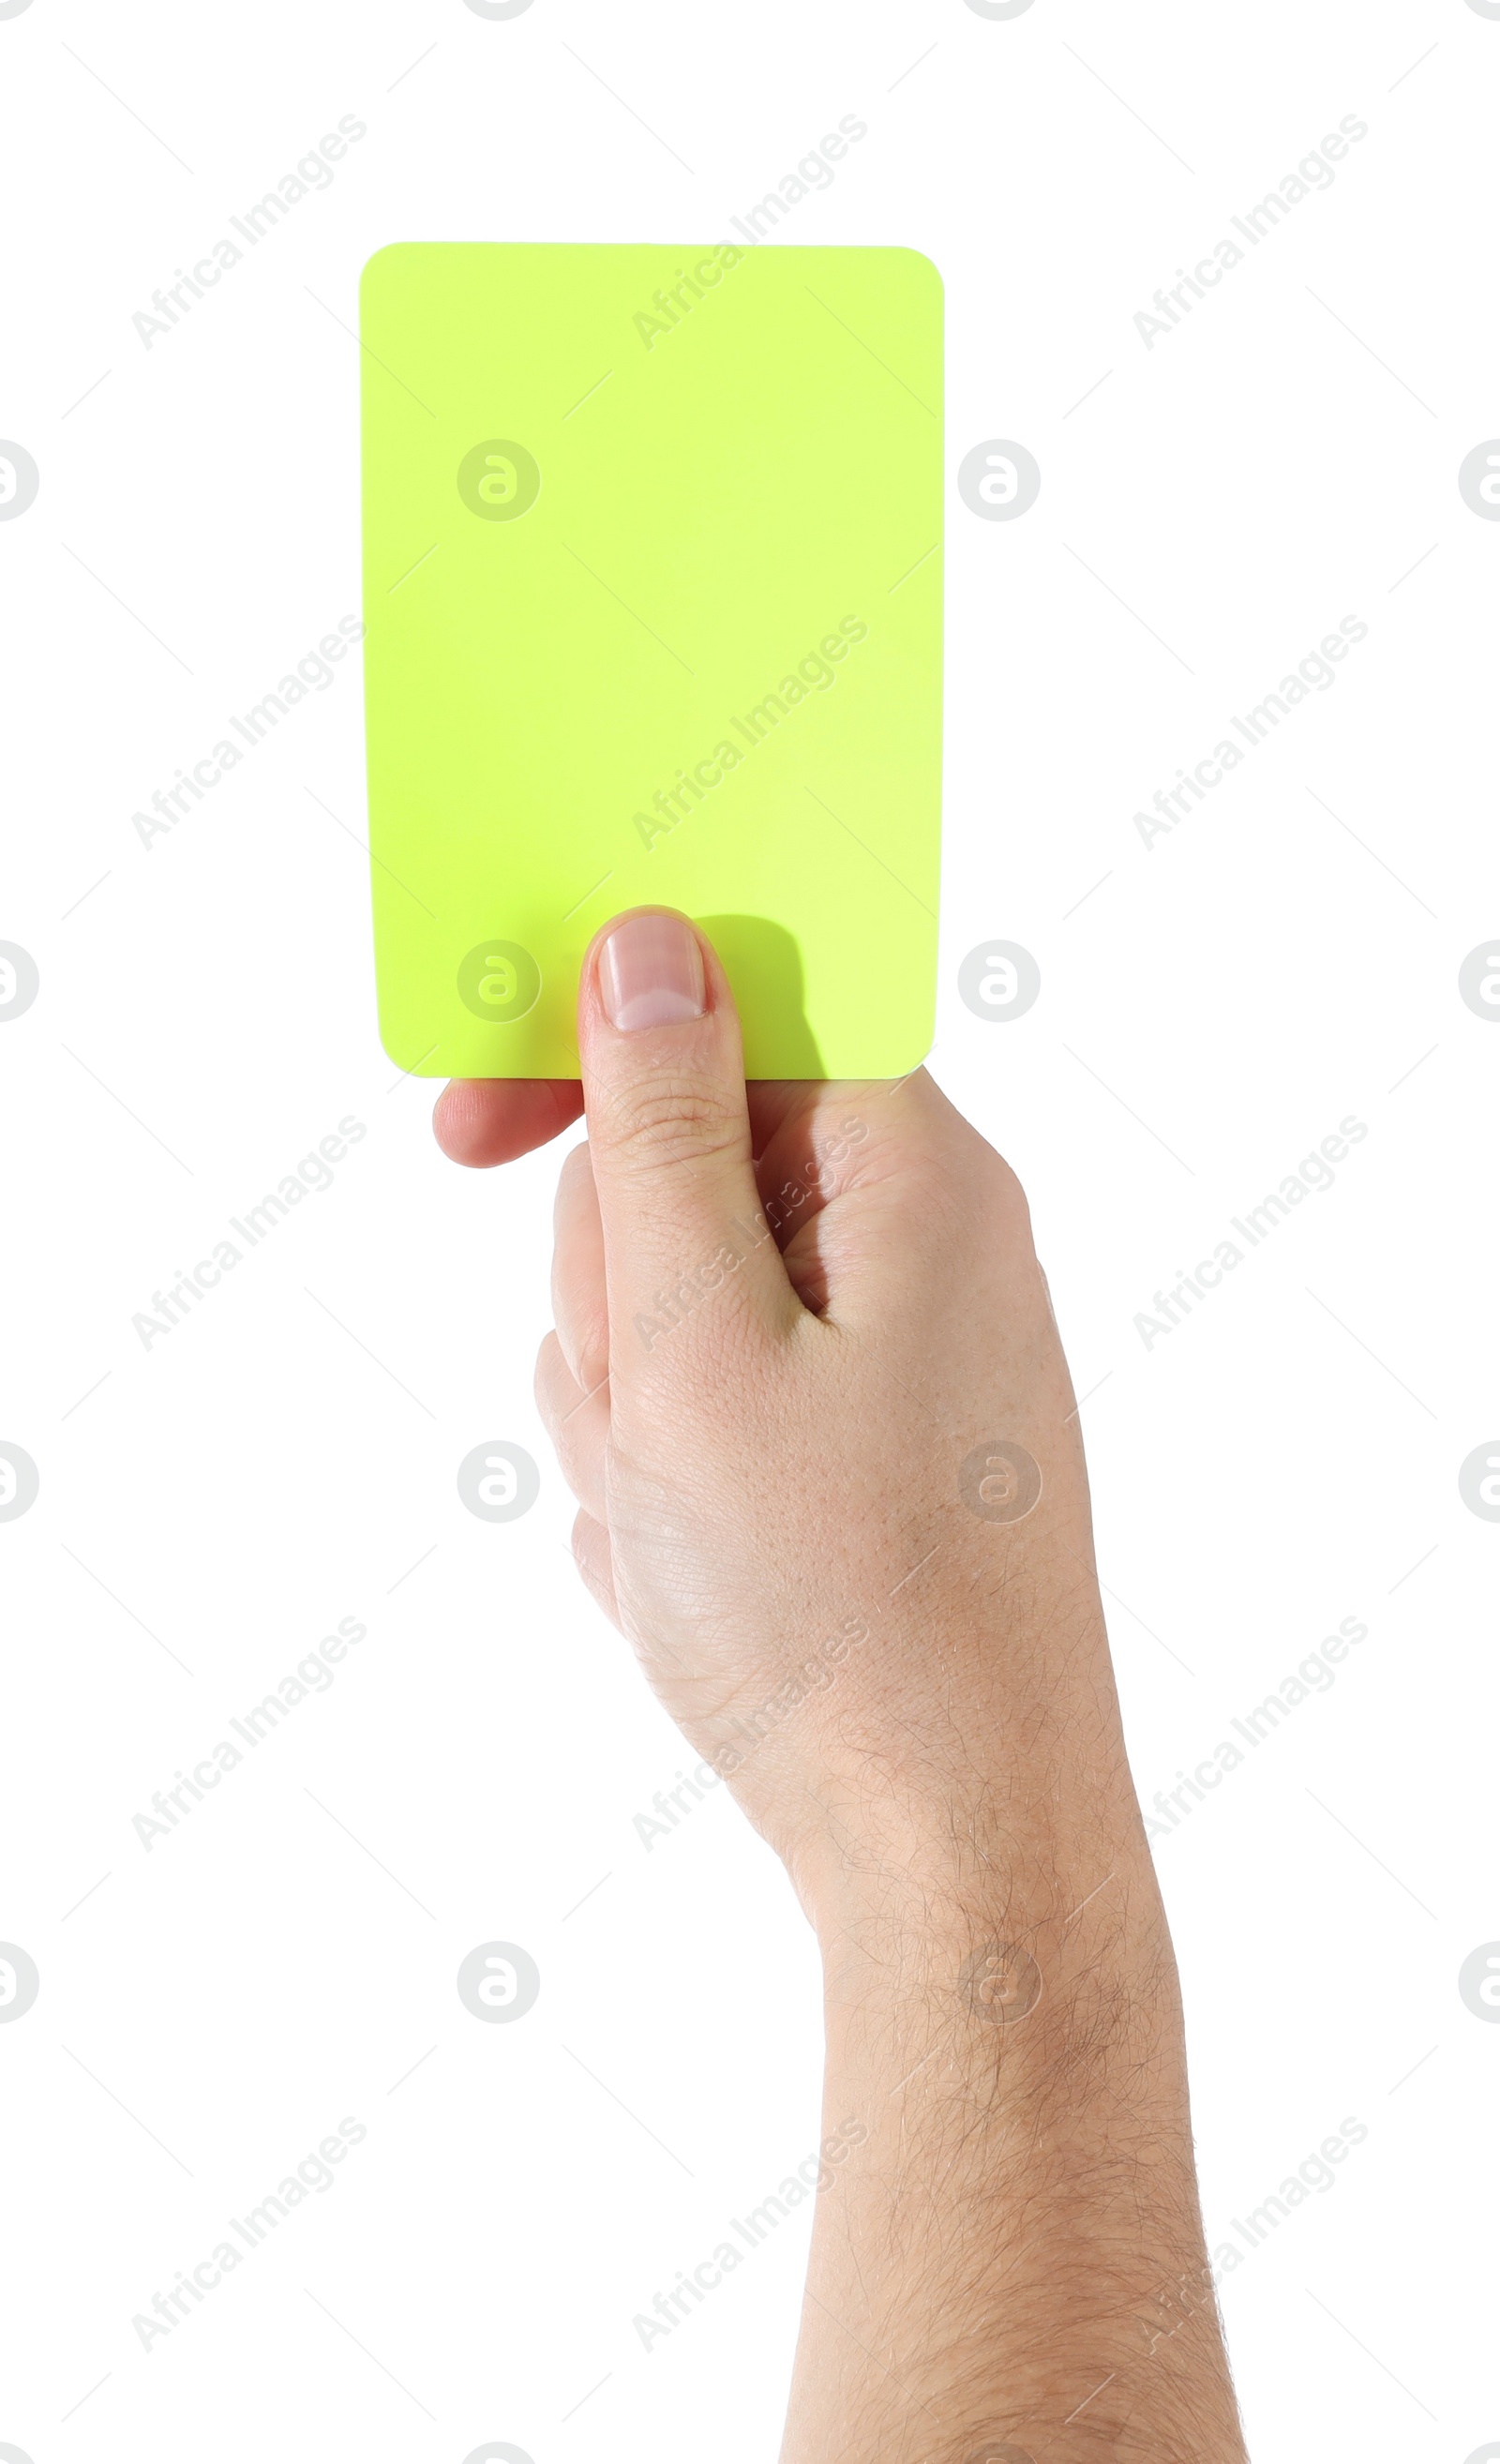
[436,909,1244,2464]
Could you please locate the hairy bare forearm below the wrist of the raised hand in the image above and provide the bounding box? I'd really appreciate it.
[783,1766,1244,2464]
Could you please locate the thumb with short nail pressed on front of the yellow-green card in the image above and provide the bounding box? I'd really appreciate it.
[578,907,801,1368]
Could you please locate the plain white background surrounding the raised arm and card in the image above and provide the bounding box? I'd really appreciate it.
[0,0,1500,2464]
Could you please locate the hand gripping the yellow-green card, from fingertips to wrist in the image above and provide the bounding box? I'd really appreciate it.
[439,911,1118,1892]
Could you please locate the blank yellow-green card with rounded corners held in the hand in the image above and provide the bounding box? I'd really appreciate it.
[360,242,943,1076]
